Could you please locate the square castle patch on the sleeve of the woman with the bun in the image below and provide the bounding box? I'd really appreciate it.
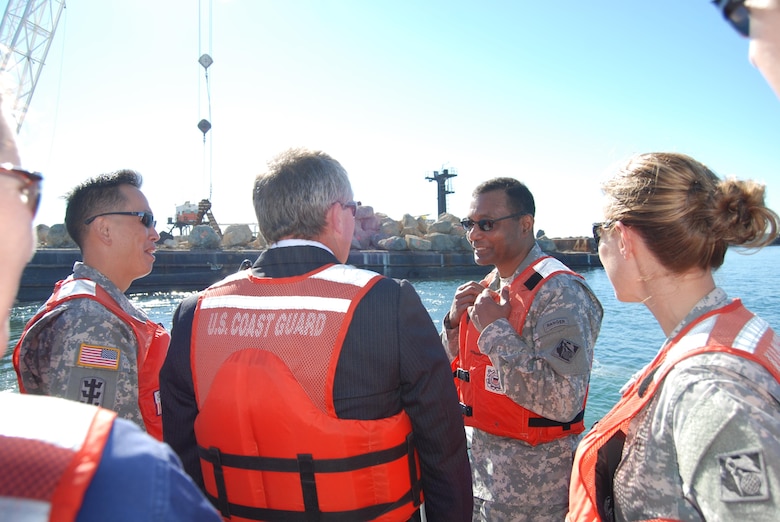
[717,449,769,502]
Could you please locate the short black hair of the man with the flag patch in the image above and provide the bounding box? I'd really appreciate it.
[65,169,143,248]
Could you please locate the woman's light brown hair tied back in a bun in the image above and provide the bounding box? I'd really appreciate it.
[602,152,778,273]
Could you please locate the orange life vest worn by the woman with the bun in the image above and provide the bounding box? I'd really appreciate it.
[566,299,780,522]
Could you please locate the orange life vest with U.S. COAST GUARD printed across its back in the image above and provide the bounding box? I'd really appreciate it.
[191,265,422,521]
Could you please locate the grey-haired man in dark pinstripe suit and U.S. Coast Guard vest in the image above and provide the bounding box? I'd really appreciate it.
[161,150,472,521]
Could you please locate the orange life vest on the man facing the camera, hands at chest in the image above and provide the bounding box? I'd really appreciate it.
[452,256,587,446]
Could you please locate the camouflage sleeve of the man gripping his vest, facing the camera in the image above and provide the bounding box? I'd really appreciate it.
[478,275,603,422]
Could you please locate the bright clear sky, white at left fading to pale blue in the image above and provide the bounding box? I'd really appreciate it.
[7,0,780,237]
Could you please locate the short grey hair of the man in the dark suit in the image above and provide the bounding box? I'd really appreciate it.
[253,149,352,243]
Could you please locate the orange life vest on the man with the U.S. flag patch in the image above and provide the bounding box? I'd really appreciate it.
[13,277,171,440]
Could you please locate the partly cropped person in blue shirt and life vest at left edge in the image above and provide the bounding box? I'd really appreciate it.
[0,91,219,522]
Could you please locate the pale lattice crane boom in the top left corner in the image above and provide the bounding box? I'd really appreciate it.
[0,0,65,133]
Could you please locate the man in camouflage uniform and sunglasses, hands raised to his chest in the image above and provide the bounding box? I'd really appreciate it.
[442,178,603,521]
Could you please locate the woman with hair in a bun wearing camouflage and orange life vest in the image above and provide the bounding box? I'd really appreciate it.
[567,149,780,521]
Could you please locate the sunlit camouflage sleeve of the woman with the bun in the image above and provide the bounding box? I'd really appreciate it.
[672,355,780,520]
